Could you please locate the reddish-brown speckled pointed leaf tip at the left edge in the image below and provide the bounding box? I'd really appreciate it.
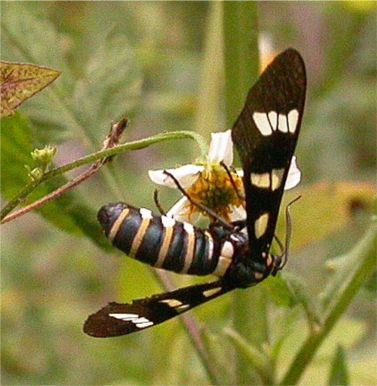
[0,61,60,117]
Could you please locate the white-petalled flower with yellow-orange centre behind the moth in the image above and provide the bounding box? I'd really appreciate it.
[149,130,301,222]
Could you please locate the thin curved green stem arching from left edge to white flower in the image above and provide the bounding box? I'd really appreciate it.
[0,131,207,220]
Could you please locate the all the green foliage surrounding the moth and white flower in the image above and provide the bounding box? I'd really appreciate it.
[1,2,377,385]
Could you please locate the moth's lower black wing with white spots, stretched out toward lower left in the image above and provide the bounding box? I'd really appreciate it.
[84,280,233,338]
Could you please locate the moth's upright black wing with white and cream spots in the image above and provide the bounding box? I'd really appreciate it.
[232,48,306,260]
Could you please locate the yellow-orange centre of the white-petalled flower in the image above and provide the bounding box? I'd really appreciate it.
[187,166,244,222]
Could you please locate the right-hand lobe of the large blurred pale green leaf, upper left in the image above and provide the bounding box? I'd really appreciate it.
[71,35,142,147]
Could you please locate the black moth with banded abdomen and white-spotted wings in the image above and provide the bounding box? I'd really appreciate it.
[84,48,306,337]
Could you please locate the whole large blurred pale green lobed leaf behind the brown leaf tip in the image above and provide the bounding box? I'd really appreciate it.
[2,4,141,150]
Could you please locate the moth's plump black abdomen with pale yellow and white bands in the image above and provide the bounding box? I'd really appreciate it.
[98,203,234,276]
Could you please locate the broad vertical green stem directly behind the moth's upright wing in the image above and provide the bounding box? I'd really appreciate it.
[223,2,260,385]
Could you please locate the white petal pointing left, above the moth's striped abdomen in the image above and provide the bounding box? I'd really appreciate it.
[148,165,204,189]
